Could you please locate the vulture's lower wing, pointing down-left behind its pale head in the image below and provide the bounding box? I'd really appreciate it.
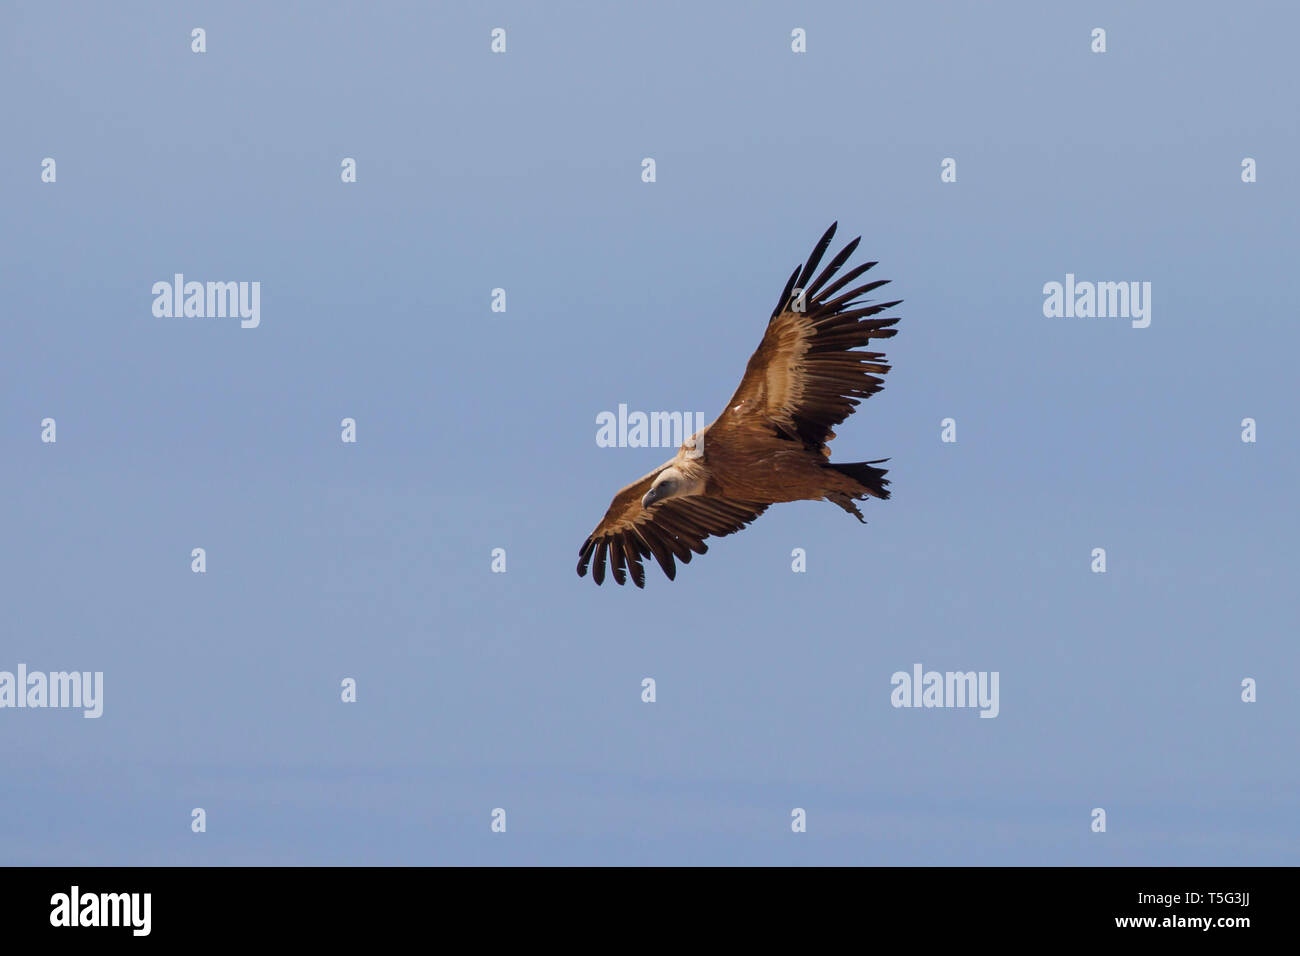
[577,462,767,588]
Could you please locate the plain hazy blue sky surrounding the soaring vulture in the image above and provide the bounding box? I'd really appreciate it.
[0,3,1300,865]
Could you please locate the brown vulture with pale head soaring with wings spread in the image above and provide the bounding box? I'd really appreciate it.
[577,222,902,588]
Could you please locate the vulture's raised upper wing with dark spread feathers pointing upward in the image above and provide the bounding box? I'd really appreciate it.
[712,224,902,455]
